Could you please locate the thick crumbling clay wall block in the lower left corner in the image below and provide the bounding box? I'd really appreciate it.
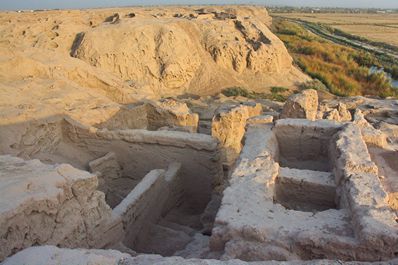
[0,156,122,260]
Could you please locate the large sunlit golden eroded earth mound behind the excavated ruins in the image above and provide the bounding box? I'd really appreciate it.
[0,7,307,129]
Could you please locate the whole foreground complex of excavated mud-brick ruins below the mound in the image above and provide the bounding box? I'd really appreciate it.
[0,87,398,265]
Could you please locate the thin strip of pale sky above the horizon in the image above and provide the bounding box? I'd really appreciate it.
[0,0,398,10]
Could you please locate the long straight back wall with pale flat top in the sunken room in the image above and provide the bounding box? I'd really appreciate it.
[67,121,222,209]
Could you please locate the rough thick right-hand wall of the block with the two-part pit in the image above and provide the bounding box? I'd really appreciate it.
[333,124,398,254]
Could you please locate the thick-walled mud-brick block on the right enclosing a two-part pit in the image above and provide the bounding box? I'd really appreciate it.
[211,119,398,261]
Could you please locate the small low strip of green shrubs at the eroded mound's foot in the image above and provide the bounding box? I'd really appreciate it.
[221,87,289,102]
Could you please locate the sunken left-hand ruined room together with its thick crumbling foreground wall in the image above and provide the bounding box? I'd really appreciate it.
[0,116,223,259]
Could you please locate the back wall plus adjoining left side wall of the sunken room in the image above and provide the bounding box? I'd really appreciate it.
[0,117,222,209]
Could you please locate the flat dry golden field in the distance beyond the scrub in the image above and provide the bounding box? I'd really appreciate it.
[272,13,398,46]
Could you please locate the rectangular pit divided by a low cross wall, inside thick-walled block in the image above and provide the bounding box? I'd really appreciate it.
[274,122,337,212]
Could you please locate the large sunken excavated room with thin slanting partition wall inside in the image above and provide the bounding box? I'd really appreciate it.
[1,116,223,256]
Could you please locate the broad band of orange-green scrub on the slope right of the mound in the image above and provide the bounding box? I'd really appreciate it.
[273,18,398,98]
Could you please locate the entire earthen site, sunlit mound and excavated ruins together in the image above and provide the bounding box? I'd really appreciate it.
[0,4,398,265]
